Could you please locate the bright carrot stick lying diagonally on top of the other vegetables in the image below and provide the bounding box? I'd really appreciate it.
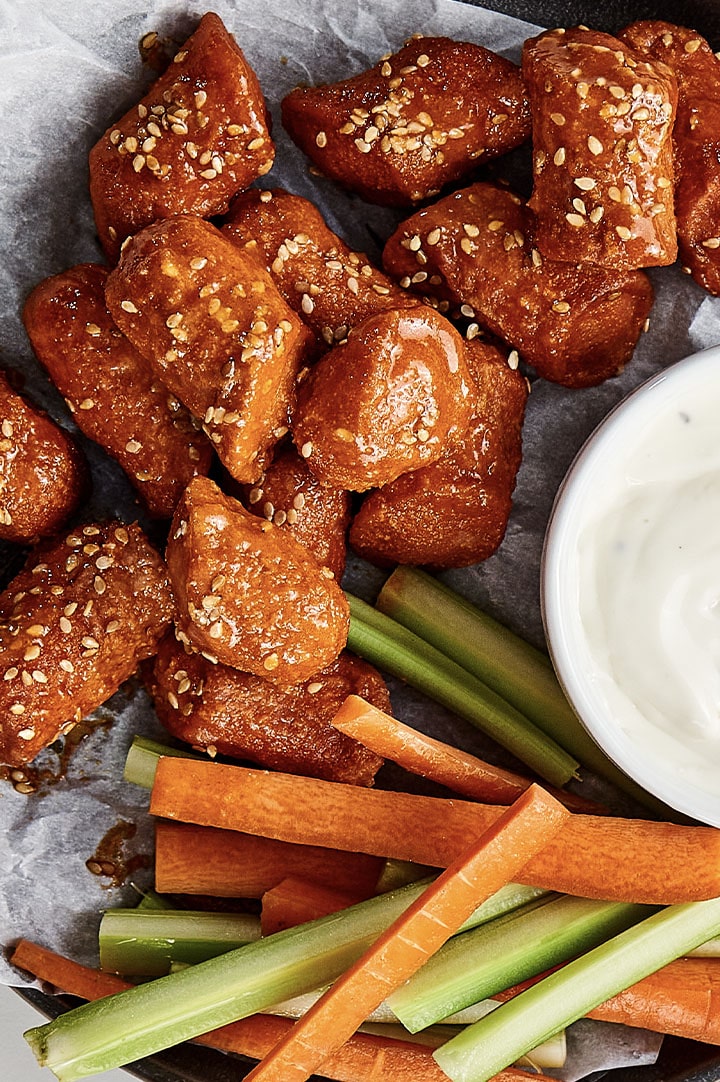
[248,786,570,1082]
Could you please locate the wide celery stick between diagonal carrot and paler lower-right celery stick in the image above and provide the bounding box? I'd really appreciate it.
[388,895,652,1043]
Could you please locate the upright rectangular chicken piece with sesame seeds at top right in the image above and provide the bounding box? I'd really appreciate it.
[523,27,678,271]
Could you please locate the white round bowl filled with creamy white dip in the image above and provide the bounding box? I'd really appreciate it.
[544,349,720,824]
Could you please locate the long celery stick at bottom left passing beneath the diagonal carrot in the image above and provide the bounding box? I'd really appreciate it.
[25,883,427,1082]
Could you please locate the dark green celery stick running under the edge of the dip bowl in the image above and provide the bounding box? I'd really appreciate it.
[376,567,666,814]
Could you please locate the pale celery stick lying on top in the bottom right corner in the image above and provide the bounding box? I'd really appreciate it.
[434,898,720,1082]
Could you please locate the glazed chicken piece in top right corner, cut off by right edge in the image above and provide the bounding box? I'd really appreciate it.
[619,21,720,296]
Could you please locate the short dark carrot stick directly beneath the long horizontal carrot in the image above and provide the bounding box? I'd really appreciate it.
[155,821,383,900]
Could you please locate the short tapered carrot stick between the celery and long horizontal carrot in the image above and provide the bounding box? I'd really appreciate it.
[332,695,606,815]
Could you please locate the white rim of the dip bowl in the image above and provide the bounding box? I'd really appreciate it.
[540,345,720,827]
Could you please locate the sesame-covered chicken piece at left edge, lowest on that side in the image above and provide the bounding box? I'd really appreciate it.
[0,522,173,766]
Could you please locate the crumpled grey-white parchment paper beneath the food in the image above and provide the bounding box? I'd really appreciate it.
[0,0,720,1077]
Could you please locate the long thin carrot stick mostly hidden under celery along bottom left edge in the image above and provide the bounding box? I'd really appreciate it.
[11,939,551,1082]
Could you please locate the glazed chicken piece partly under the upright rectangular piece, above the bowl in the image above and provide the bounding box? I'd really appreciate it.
[383,184,653,387]
